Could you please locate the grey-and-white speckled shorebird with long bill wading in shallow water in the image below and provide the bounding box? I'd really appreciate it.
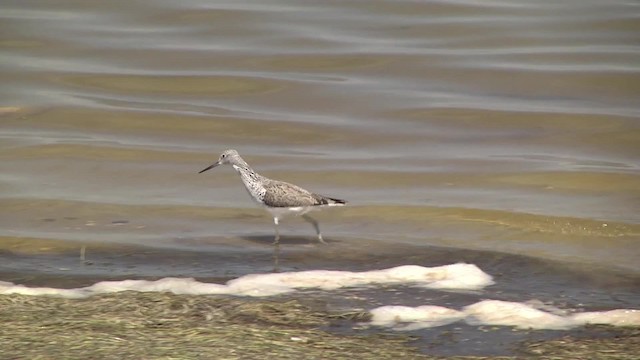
[199,149,347,245]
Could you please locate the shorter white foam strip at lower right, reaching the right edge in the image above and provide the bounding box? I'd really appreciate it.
[369,300,640,330]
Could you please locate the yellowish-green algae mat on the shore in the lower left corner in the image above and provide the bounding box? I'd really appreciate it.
[0,292,420,359]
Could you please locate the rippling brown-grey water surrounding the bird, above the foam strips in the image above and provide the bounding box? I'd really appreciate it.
[0,0,640,356]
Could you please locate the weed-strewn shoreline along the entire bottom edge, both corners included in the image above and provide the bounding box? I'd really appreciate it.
[0,292,640,359]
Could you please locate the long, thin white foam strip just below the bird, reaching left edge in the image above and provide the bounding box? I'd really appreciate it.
[0,264,493,298]
